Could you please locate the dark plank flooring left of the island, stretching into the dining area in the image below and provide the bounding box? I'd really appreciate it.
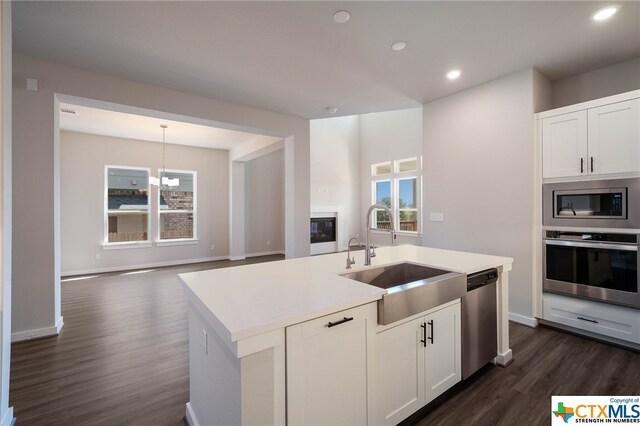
[9,256,283,425]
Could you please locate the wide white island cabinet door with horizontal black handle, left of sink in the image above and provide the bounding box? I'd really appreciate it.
[286,303,376,425]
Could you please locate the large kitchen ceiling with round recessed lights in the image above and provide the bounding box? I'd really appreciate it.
[12,1,640,118]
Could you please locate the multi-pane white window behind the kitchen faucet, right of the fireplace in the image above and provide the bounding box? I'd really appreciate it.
[371,157,420,233]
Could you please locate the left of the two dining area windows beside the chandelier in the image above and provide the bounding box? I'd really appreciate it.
[105,166,149,243]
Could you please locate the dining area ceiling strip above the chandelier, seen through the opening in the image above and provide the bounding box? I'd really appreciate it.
[60,103,281,149]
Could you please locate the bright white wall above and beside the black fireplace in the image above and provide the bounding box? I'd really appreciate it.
[310,115,361,250]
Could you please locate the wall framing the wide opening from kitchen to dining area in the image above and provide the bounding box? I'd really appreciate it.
[12,55,309,340]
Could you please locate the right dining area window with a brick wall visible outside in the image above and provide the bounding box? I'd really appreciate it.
[158,170,196,241]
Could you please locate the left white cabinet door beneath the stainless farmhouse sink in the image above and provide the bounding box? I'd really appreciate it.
[369,317,425,425]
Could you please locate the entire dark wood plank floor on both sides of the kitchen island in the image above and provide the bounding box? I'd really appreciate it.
[9,257,640,426]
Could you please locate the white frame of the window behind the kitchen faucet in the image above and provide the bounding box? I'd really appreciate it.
[371,156,422,237]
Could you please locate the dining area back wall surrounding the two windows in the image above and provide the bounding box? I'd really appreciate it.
[60,132,229,275]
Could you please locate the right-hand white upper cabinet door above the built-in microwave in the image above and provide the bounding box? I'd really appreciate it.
[588,99,640,175]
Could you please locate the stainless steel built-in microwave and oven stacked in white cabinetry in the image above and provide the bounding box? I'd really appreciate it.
[543,178,640,309]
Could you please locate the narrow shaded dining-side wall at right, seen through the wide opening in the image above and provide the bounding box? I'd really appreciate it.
[244,149,284,256]
